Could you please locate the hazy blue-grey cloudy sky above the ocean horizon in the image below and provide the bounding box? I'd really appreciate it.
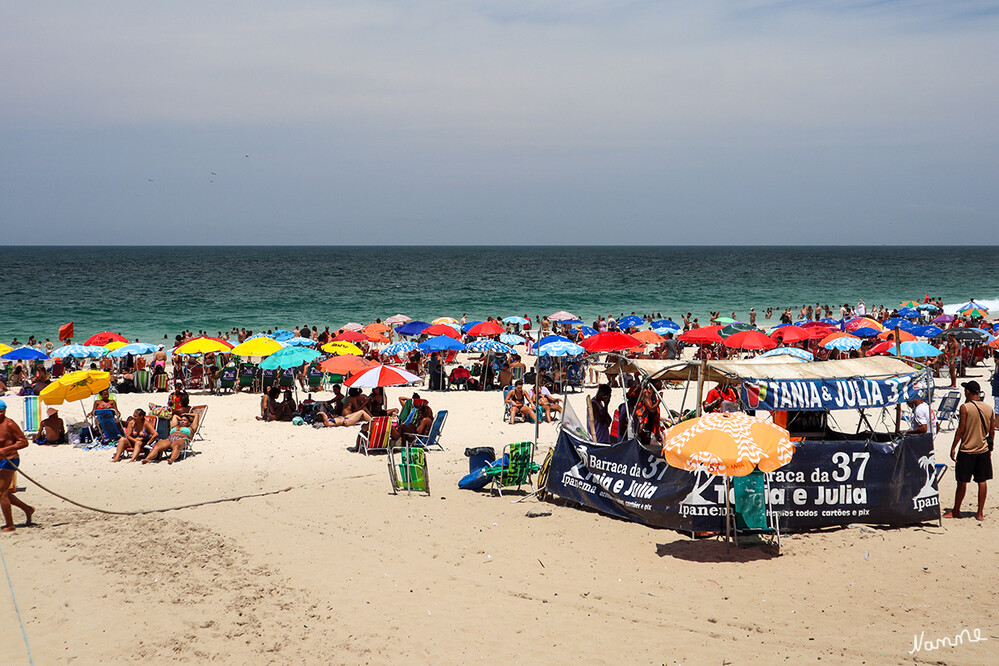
[0,0,999,245]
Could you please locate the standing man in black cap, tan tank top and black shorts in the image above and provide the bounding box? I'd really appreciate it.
[944,381,996,520]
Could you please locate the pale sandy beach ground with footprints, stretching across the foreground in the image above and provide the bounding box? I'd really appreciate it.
[0,358,999,664]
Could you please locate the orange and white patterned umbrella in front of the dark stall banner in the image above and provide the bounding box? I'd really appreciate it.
[663,412,794,476]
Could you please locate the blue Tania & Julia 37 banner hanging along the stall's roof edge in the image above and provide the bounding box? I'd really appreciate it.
[740,372,926,412]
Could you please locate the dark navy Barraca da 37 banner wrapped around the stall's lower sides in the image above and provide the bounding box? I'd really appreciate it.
[545,431,940,532]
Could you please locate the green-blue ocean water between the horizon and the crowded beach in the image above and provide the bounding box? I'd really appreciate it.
[0,246,999,343]
